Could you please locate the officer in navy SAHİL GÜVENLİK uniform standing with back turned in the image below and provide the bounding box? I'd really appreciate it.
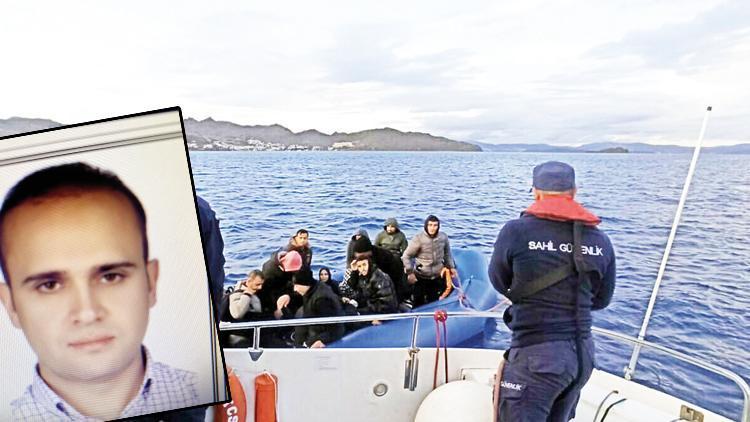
[488,161,615,421]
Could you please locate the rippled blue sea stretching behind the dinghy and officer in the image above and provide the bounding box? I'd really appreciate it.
[190,152,750,419]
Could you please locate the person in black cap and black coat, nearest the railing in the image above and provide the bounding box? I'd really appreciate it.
[292,272,344,349]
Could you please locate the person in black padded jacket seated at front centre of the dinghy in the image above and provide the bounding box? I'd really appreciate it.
[339,258,398,315]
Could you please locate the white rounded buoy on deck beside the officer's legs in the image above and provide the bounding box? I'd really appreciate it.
[414,381,494,422]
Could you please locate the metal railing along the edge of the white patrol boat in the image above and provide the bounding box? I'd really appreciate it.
[219,311,750,422]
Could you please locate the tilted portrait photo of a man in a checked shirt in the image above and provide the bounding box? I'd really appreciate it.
[0,108,227,420]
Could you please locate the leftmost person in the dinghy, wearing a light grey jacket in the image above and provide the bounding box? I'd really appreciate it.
[221,270,268,322]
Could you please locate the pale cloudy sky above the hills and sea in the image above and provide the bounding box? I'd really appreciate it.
[0,0,750,146]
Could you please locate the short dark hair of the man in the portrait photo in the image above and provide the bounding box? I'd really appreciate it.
[0,162,148,285]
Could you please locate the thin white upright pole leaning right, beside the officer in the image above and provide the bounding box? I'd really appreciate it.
[624,106,711,380]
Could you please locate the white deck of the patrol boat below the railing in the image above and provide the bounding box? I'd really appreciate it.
[219,348,728,422]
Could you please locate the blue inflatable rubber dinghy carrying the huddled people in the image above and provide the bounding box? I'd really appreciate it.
[328,249,502,348]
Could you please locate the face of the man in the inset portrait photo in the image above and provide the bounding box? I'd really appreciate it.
[0,190,158,382]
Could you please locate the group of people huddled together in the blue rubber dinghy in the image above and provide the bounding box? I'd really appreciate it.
[214,215,456,348]
